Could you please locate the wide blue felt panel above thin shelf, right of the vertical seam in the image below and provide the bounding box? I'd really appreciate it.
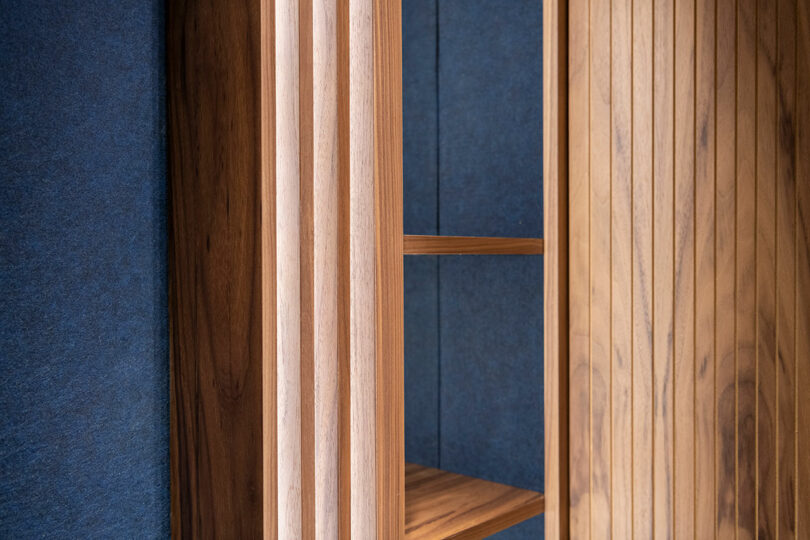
[438,0,543,236]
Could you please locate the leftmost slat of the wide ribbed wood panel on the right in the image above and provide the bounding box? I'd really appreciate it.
[564,0,592,538]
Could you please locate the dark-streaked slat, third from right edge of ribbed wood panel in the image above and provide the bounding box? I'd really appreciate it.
[755,0,778,538]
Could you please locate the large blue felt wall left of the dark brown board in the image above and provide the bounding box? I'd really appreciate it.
[0,0,169,538]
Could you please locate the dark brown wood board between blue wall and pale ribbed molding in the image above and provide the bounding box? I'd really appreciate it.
[166,1,272,538]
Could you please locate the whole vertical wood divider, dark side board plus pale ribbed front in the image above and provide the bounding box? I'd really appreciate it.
[167,0,404,539]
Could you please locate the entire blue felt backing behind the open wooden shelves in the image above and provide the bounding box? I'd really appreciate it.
[403,0,544,540]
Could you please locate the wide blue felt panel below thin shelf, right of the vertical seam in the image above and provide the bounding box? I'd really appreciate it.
[439,255,543,491]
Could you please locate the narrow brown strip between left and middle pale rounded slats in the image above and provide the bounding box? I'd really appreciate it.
[298,1,316,540]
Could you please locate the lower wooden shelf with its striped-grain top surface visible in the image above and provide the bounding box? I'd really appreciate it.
[405,463,545,539]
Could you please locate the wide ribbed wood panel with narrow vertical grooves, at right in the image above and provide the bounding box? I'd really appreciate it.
[568,0,810,538]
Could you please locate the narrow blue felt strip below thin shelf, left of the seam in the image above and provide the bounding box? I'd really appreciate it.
[405,256,439,467]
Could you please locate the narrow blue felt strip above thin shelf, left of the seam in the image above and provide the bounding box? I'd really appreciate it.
[402,0,438,234]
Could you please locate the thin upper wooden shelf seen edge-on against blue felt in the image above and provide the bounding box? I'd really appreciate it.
[403,234,543,255]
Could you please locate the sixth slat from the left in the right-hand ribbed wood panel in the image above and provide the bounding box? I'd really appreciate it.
[673,0,695,538]
